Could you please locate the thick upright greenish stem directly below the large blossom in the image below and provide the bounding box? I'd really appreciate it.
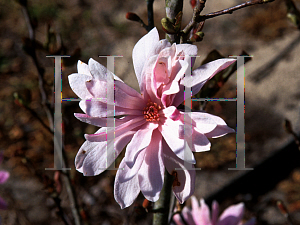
[153,171,174,225]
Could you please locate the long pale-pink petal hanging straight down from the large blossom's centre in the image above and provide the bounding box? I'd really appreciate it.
[138,130,165,202]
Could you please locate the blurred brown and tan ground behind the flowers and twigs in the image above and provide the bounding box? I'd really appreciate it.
[0,0,300,225]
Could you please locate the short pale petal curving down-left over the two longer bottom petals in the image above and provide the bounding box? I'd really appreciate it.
[125,123,158,168]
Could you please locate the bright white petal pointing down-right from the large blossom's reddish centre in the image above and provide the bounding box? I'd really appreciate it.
[159,119,196,164]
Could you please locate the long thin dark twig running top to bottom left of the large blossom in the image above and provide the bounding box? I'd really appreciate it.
[22,5,82,225]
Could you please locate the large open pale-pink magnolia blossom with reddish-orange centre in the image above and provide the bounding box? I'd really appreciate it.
[69,28,235,208]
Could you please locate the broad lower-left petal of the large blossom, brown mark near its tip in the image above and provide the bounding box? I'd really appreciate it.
[75,128,134,176]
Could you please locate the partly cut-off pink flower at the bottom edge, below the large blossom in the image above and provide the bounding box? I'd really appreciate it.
[173,196,255,225]
